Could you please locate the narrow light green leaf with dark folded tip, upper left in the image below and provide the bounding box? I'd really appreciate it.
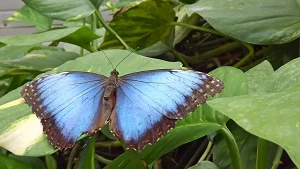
[0,26,99,48]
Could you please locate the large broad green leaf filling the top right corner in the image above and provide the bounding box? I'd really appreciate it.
[185,0,300,44]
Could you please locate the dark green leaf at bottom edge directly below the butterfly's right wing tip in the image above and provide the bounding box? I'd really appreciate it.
[104,149,145,169]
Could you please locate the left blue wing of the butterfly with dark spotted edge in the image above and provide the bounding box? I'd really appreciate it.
[21,72,109,149]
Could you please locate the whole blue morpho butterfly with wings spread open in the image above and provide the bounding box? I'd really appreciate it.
[21,51,223,151]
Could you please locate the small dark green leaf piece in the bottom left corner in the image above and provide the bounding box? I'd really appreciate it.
[0,155,33,169]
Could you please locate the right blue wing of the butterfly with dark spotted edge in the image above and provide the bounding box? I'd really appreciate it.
[110,70,223,151]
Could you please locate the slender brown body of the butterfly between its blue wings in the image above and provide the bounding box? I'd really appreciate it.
[103,69,119,100]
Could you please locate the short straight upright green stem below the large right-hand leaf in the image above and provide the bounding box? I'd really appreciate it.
[256,138,269,169]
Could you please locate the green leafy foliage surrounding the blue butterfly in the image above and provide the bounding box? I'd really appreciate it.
[0,0,300,169]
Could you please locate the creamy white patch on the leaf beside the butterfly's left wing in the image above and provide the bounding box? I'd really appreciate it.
[0,114,46,155]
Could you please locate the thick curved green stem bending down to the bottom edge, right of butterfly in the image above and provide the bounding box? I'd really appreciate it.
[219,127,243,169]
